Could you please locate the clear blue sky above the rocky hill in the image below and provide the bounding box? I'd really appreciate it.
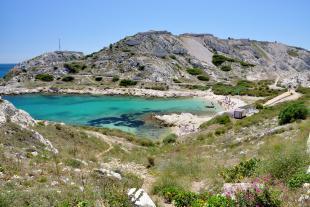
[0,0,310,63]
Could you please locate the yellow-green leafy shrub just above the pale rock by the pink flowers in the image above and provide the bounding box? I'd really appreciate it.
[221,158,259,182]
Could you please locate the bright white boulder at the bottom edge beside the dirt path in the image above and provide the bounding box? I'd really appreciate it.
[128,188,156,207]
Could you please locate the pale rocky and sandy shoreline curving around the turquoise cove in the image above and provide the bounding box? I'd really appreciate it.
[0,86,246,136]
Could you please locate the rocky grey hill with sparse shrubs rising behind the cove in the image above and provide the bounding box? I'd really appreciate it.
[2,31,310,89]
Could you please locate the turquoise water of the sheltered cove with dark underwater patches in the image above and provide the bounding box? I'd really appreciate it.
[4,94,219,137]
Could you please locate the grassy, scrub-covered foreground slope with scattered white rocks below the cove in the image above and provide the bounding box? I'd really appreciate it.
[0,88,310,207]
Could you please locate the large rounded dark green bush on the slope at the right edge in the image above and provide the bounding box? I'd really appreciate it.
[278,103,308,125]
